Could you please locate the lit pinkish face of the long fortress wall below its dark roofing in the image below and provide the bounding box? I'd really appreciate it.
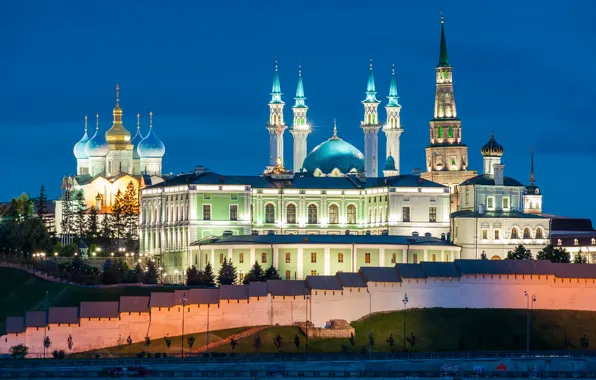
[0,275,596,355]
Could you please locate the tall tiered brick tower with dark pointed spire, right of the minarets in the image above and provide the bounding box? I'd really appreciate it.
[421,13,476,197]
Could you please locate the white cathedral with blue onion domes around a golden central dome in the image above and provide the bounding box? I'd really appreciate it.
[55,86,165,234]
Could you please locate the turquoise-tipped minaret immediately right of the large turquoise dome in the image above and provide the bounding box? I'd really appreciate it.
[360,58,381,178]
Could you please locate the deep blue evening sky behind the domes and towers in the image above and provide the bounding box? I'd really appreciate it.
[0,0,596,217]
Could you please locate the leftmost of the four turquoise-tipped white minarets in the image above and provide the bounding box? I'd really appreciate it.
[267,60,287,168]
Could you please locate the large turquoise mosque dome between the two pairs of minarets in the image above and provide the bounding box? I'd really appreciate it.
[302,136,364,175]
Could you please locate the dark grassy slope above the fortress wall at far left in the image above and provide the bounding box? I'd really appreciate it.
[0,267,172,335]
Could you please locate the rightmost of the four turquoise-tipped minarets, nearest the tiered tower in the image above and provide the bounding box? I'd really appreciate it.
[383,64,404,177]
